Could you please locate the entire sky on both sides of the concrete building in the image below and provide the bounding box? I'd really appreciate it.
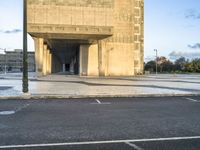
[0,0,200,61]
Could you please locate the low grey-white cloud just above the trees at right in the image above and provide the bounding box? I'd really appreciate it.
[169,51,200,60]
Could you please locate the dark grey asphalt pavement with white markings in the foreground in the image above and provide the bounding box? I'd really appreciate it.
[0,97,200,150]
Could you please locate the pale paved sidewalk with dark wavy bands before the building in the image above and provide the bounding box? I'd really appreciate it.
[0,74,200,99]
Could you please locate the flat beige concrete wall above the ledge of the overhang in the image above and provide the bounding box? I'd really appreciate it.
[28,0,113,26]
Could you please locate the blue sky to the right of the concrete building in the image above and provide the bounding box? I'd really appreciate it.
[144,0,200,59]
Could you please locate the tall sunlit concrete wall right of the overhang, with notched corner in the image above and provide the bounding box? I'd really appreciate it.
[106,0,144,76]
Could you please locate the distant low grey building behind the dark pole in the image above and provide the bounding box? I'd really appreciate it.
[0,49,35,72]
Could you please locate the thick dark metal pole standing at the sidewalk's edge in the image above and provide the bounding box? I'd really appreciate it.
[22,0,28,93]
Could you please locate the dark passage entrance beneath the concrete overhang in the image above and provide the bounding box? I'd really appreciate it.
[49,40,80,75]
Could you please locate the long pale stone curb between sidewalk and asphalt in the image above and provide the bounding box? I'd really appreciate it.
[0,94,200,100]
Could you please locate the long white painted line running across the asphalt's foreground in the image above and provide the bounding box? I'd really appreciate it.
[0,136,200,149]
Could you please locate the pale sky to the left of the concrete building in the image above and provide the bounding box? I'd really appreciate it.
[0,0,34,52]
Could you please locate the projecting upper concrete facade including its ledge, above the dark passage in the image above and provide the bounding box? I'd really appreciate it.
[27,0,113,39]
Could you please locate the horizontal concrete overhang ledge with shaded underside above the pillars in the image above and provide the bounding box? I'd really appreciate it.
[28,23,113,40]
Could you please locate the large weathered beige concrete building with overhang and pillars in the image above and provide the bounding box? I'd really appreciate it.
[27,0,144,76]
